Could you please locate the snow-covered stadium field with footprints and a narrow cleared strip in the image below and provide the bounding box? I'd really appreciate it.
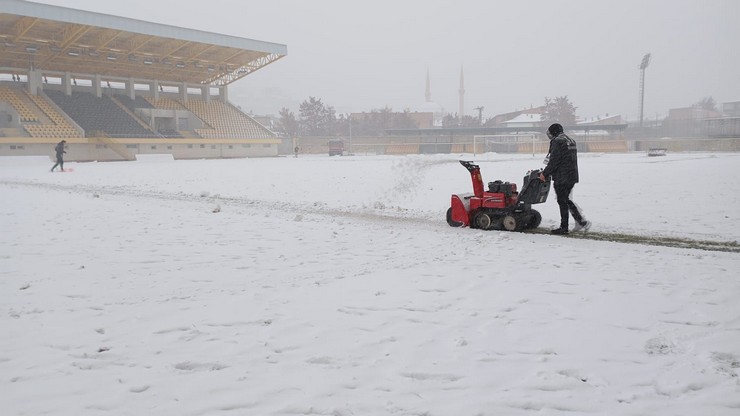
[0,153,740,416]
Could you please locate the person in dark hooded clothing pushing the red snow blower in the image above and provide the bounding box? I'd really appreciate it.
[540,123,591,234]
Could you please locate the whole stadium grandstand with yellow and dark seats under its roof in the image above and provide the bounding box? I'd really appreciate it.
[0,0,287,161]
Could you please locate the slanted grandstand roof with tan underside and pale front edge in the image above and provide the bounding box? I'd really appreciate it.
[0,0,287,85]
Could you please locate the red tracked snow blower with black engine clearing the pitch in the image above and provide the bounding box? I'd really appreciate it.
[447,160,550,231]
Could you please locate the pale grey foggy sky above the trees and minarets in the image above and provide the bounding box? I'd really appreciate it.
[30,0,740,120]
